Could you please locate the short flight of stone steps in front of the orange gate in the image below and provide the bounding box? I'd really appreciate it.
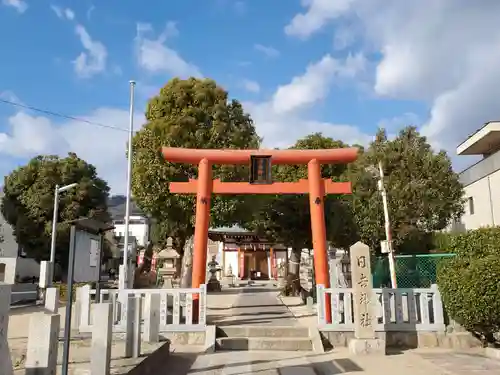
[215,326,313,351]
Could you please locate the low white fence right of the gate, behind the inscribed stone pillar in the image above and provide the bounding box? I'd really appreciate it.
[317,285,445,332]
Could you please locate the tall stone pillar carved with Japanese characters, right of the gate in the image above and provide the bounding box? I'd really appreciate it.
[349,242,385,355]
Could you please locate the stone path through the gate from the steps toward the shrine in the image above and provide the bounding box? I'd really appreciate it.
[211,286,298,326]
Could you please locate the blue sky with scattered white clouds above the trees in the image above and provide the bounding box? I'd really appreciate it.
[0,0,500,192]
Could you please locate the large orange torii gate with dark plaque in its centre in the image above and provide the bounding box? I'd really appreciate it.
[162,147,358,322]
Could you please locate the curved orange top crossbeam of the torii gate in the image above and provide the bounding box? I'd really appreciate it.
[162,147,358,165]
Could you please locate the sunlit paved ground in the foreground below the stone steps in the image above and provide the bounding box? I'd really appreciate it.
[165,349,476,375]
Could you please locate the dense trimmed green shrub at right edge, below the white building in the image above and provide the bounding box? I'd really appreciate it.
[437,228,500,344]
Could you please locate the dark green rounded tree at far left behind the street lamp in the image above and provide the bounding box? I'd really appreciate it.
[1,153,109,270]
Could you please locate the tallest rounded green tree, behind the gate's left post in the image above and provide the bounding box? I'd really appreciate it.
[132,78,260,285]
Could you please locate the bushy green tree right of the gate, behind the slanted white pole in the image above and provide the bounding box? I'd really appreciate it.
[349,127,463,252]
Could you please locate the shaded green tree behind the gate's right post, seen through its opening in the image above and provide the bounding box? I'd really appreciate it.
[247,133,358,290]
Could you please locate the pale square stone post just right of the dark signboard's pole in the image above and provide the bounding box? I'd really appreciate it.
[90,303,113,375]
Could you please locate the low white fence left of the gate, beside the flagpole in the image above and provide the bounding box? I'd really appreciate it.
[76,285,207,332]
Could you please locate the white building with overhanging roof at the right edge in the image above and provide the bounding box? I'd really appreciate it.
[452,121,500,231]
